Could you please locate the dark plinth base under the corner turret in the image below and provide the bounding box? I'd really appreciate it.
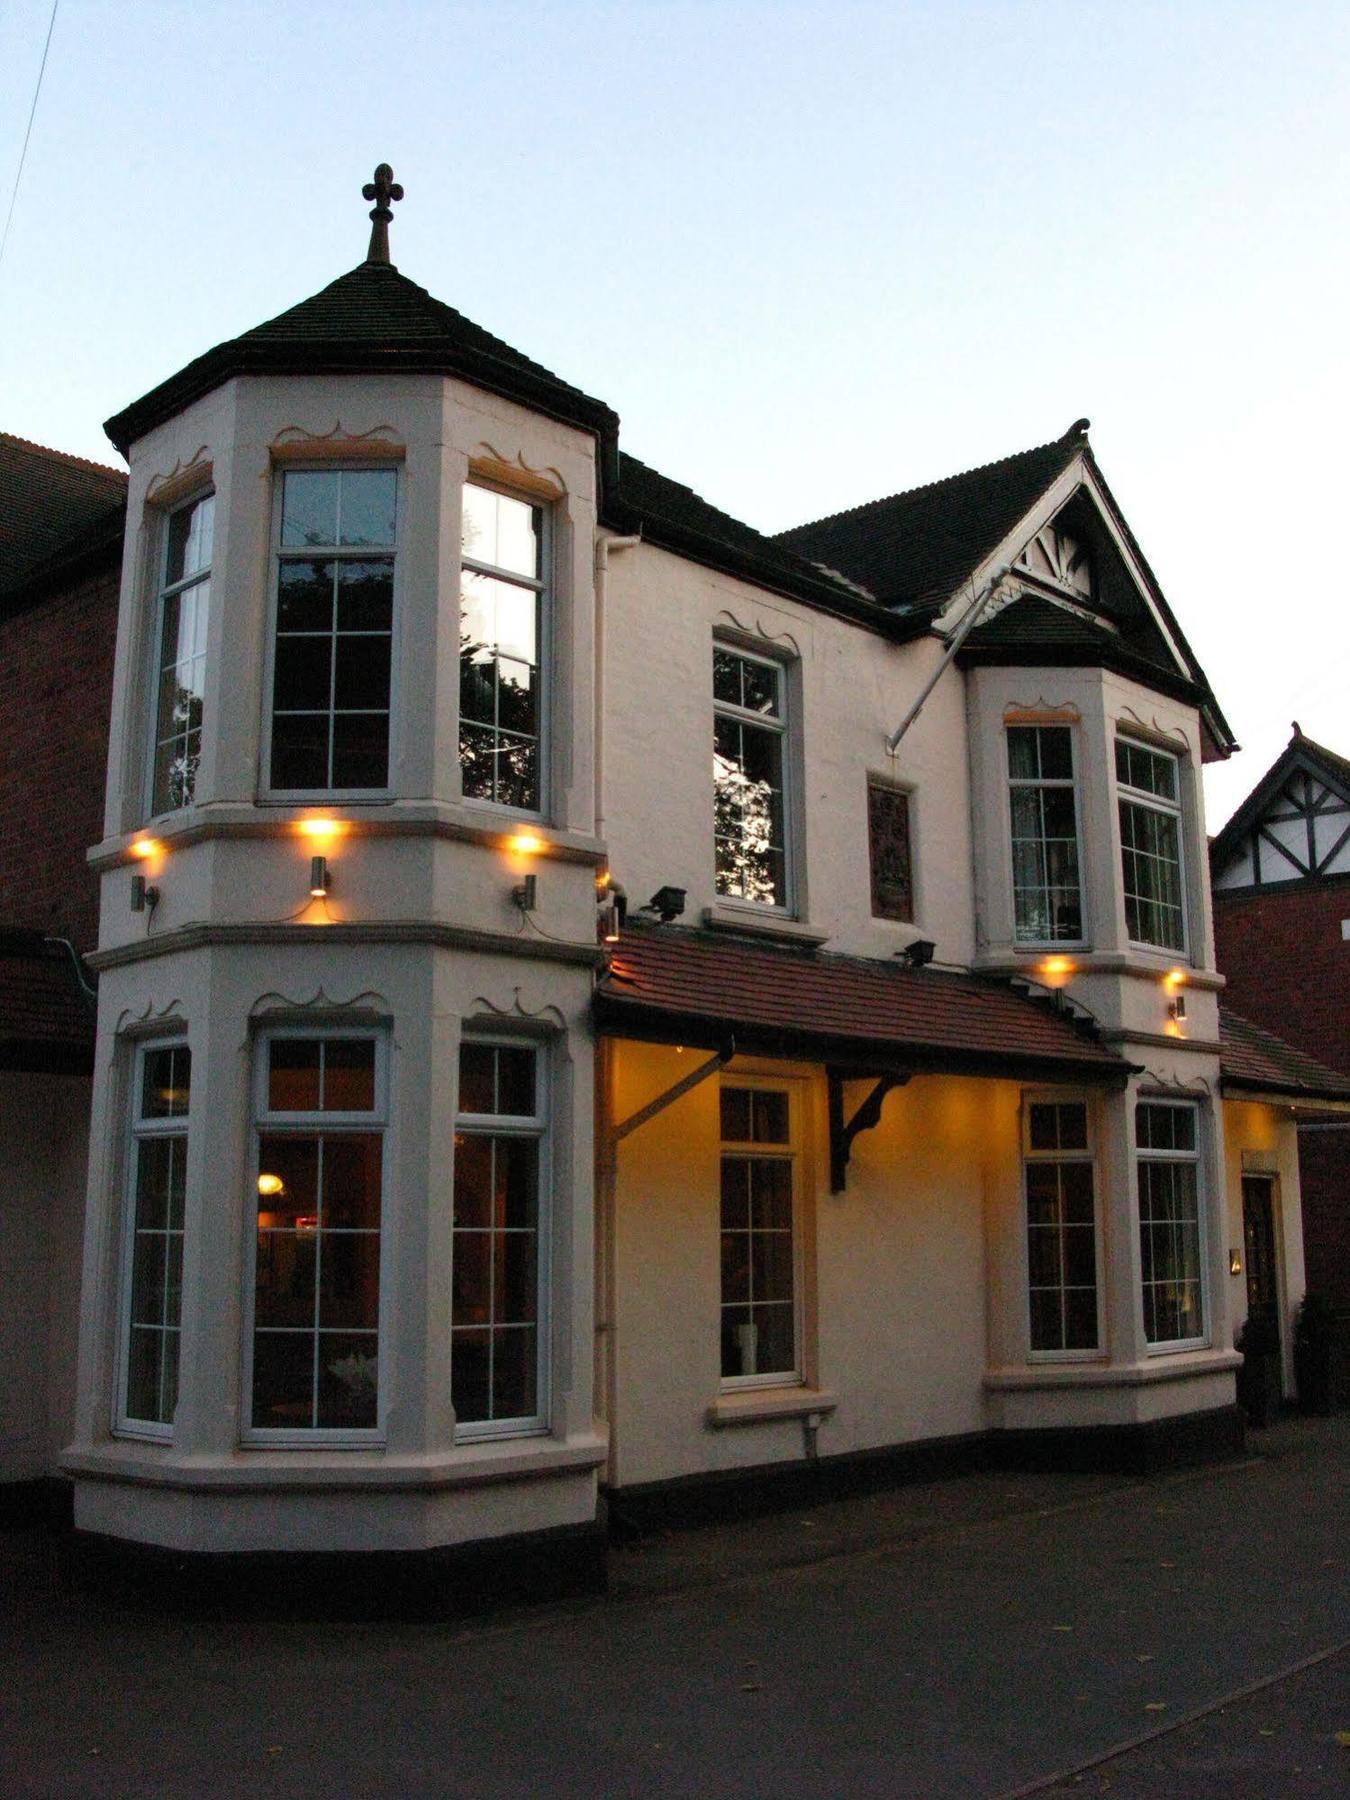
[65,1521,607,1620]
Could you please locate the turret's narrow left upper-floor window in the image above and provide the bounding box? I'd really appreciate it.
[149,493,216,814]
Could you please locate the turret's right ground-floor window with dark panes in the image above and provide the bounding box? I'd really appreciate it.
[450,1035,553,1442]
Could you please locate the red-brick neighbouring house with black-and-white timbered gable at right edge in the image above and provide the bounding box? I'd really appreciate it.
[1210,725,1350,1309]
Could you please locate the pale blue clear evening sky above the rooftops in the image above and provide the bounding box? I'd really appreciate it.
[0,0,1350,830]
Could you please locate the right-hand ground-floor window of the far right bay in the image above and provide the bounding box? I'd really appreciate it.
[1134,1096,1210,1354]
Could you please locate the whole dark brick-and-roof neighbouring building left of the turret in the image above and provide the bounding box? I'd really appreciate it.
[0,432,126,1492]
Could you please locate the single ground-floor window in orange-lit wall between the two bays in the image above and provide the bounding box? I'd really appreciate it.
[718,1076,805,1391]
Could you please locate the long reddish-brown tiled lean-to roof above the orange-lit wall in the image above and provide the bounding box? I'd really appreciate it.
[596,925,1129,1084]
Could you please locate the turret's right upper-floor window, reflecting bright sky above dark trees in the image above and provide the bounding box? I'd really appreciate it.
[459,481,547,812]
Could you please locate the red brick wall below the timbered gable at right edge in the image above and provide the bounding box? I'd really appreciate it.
[1213,875,1350,1075]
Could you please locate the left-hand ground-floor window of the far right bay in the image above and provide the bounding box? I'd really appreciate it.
[1022,1093,1102,1363]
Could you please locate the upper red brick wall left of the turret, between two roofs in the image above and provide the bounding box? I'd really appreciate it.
[0,569,119,950]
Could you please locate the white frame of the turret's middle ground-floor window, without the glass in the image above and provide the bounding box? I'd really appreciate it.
[239,1021,392,1449]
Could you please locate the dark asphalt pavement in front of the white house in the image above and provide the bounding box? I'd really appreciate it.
[0,1417,1350,1800]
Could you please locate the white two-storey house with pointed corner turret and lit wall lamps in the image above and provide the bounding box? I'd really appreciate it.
[0,169,1350,1591]
